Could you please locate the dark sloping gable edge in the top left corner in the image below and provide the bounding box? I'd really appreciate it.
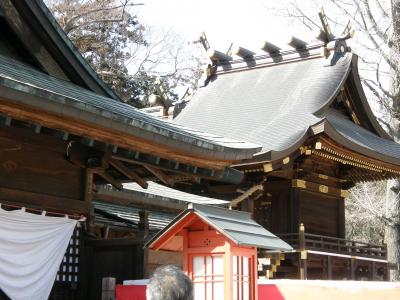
[0,0,119,100]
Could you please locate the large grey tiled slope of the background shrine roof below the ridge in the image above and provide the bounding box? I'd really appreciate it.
[174,54,351,159]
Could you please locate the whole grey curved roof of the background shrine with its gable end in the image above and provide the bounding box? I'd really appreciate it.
[174,47,400,165]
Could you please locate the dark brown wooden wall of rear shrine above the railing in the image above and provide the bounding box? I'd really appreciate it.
[253,180,345,238]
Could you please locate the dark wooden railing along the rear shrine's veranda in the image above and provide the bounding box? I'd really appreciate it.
[278,231,387,259]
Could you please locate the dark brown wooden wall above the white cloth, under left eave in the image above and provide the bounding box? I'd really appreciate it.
[0,125,85,209]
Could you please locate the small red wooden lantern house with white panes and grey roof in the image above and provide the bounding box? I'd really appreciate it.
[147,205,290,300]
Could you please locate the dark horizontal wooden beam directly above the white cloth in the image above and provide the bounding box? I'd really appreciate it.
[0,187,88,215]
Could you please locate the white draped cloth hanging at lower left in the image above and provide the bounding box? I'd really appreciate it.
[0,208,78,300]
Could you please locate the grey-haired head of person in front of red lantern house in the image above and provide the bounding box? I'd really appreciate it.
[146,265,193,300]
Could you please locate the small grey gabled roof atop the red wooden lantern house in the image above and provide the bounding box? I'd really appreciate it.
[145,204,293,251]
